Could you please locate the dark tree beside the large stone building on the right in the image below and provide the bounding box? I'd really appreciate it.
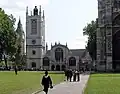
[83,21,97,60]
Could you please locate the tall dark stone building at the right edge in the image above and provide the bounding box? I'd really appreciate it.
[96,0,120,71]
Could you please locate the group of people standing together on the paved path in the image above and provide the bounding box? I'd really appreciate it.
[65,69,80,82]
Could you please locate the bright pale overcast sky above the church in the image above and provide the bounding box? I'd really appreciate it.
[0,0,97,49]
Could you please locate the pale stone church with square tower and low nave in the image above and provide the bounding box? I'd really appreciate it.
[26,6,91,71]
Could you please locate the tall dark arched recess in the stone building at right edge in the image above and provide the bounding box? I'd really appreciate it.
[112,14,120,71]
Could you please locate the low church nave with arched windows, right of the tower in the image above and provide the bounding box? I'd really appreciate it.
[42,43,92,71]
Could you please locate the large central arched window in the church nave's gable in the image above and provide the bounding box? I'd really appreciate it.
[55,48,63,62]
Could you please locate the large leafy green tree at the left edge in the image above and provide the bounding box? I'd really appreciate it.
[0,8,17,68]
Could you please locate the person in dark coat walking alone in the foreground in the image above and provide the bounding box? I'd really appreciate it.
[41,71,53,94]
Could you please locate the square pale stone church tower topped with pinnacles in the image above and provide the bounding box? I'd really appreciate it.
[26,6,45,69]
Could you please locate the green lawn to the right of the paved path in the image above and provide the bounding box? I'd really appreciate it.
[84,74,120,94]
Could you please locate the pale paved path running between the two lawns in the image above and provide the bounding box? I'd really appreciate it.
[38,74,89,94]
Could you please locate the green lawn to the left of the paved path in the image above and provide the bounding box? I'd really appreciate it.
[0,72,64,94]
